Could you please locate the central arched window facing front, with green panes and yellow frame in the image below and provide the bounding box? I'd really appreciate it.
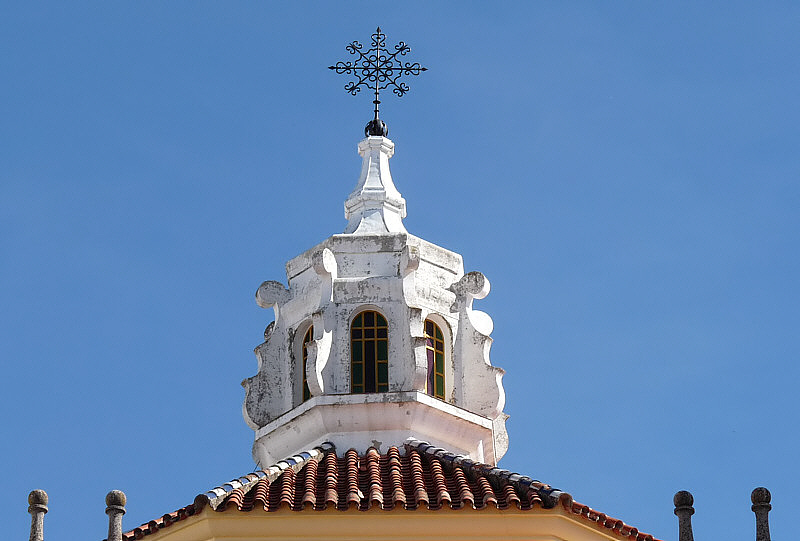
[350,310,389,393]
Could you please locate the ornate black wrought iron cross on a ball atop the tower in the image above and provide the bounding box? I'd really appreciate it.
[328,27,428,136]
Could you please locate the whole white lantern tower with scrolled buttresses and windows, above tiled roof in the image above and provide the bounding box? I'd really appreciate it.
[243,129,508,467]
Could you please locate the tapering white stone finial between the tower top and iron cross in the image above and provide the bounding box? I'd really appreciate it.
[344,136,407,235]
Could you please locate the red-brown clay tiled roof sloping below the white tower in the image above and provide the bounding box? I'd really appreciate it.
[117,440,654,541]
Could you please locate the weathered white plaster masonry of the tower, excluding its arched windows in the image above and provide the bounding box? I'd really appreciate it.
[242,146,507,460]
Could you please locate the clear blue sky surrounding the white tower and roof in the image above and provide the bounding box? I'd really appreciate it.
[0,1,800,541]
